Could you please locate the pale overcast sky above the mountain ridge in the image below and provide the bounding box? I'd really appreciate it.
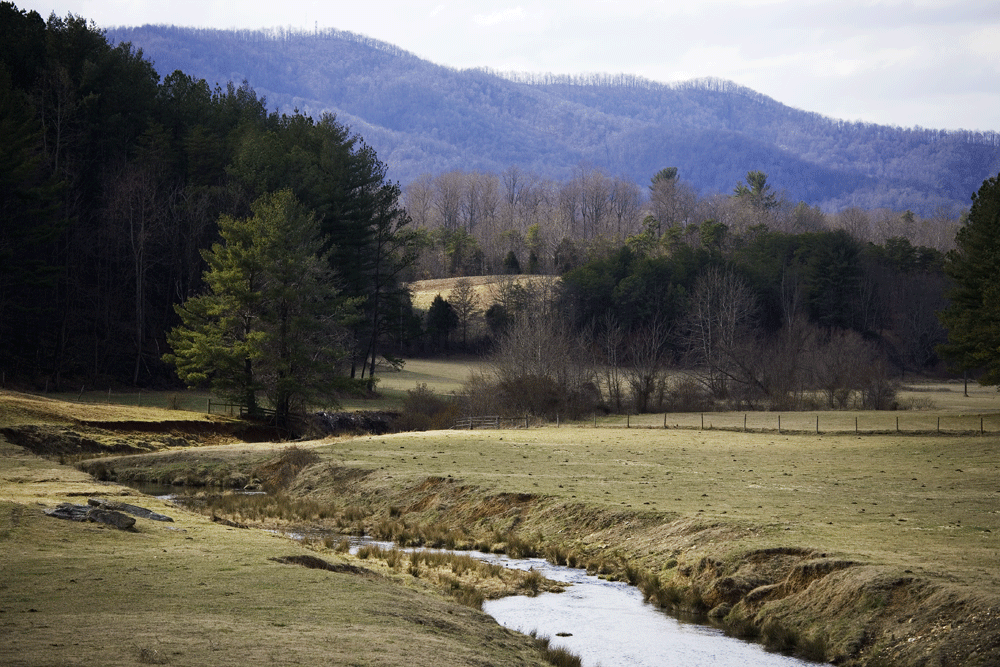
[14,0,1000,130]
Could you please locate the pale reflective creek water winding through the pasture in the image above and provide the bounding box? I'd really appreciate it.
[142,486,817,667]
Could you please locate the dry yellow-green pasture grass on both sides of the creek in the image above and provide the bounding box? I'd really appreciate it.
[0,376,1000,665]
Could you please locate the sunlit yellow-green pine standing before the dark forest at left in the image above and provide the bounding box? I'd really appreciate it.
[164,190,350,426]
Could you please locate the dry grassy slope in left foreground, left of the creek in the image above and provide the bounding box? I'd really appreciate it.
[0,439,556,667]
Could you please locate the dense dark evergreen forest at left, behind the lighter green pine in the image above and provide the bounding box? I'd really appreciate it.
[0,2,411,410]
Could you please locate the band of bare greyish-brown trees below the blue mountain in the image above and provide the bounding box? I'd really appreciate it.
[403,164,963,279]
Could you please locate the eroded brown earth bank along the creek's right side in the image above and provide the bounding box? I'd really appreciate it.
[289,466,1000,666]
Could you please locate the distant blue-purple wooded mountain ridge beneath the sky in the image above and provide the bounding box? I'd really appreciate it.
[106,26,1000,215]
